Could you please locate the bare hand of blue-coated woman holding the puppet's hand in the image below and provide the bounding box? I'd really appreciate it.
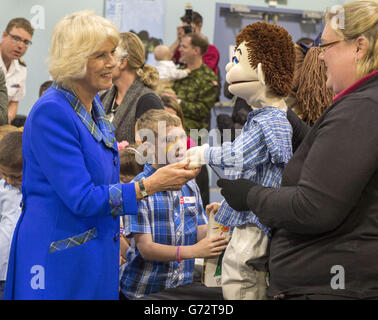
[144,161,200,195]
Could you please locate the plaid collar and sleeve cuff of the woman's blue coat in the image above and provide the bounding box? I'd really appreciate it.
[52,82,124,216]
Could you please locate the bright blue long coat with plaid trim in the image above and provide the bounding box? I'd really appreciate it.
[4,84,138,299]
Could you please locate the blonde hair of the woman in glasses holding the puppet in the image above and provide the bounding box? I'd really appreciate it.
[326,1,378,79]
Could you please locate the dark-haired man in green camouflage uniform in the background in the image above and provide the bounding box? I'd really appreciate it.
[173,32,219,130]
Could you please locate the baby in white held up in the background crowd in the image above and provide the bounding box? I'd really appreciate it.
[154,45,190,81]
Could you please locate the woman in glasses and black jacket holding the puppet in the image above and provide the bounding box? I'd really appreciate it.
[219,1,378,299]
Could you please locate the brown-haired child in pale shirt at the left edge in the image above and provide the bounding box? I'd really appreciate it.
[0,129,23,300]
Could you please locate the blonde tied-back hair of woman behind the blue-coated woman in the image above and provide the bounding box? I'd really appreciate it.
[117,32,159,90]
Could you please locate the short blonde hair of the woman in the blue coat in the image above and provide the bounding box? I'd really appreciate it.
[48,11,119,89]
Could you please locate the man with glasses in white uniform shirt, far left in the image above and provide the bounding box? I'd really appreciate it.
[0,18,34,123]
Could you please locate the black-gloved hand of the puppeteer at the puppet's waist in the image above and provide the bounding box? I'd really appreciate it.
[217,179,256,211]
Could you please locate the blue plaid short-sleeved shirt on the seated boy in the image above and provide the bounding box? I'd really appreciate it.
[121,163,207,299]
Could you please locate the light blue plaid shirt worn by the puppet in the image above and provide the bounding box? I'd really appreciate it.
[205,107,292,236]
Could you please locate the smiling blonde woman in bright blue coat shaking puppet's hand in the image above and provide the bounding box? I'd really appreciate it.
[4,11,198,299]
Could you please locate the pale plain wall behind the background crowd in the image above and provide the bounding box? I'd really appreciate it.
[0,0,346,114]
